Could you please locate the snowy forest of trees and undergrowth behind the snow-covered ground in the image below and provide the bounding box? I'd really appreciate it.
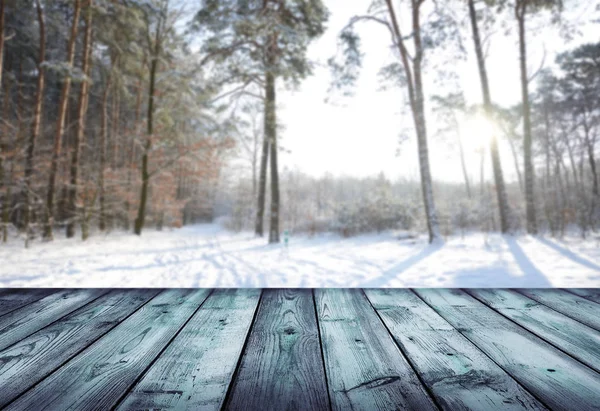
[0,0,600,251]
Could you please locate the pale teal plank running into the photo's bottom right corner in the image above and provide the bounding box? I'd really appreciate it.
[415,288,600,410]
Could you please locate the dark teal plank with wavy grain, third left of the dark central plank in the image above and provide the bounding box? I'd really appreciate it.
[0,289,159,408]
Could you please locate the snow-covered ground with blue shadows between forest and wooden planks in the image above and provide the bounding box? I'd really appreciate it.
[0,224,600,287]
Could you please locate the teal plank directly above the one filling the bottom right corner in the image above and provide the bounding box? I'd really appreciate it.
[468,288,600,372]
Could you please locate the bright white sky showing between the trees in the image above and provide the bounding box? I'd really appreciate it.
[278,0,598,181]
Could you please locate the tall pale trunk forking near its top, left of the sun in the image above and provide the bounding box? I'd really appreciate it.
[386,0,442,243]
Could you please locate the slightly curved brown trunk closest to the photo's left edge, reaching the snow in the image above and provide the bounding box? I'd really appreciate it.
[23,0,46,238]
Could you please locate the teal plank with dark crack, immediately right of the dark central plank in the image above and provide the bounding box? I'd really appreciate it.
[315,289,437,410]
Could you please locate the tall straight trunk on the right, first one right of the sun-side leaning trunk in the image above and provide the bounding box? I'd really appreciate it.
[515,0,538,234]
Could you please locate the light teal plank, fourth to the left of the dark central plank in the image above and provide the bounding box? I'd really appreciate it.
[0,288,108,350]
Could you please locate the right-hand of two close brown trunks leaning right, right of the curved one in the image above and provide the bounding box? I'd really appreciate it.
[67,0,93,238]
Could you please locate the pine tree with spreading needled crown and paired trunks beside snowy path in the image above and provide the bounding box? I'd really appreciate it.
[194,0,328,243]
